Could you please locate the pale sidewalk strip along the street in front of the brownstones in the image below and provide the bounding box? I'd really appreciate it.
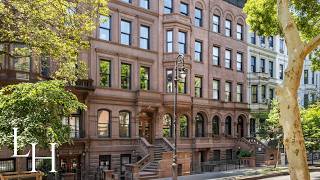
[159,167,272,180]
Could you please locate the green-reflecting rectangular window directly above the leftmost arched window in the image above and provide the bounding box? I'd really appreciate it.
[99,59,111,87]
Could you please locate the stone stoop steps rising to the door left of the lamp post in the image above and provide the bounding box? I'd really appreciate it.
[139,141,168,179]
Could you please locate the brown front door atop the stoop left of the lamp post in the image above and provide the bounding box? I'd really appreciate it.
[139,112,152,143]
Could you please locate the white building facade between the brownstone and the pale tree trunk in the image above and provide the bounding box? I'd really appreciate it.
[247,28,288,137]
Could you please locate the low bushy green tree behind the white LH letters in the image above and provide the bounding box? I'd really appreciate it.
[0,80,85,150]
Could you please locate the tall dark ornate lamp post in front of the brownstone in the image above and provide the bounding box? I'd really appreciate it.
[172,54,187,180]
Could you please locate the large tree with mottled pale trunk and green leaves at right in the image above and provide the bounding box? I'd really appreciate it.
[244,0,320,180]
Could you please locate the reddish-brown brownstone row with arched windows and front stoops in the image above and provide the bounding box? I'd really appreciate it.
[0,0,274,179]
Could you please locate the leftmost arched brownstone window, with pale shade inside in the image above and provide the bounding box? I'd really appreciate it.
[98,110,111,137]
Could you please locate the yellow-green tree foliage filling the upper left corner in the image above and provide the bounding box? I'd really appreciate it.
[0,0,108,82]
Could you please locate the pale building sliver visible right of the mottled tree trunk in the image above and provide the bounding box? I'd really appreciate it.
[298,54,320,108]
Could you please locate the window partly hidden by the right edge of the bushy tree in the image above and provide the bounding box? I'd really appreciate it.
[62,110,81,138]
